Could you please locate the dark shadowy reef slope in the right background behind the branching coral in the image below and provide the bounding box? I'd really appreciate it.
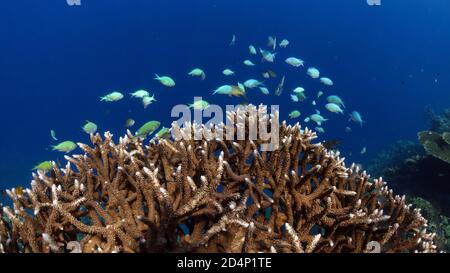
[366,107,450,251]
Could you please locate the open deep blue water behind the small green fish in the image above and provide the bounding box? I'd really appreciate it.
[0,0,450,197]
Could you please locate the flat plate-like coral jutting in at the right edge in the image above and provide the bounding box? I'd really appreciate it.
[418,131,450,164]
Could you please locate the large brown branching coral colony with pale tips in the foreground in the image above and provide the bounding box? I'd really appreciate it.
[0,105,436,252]
